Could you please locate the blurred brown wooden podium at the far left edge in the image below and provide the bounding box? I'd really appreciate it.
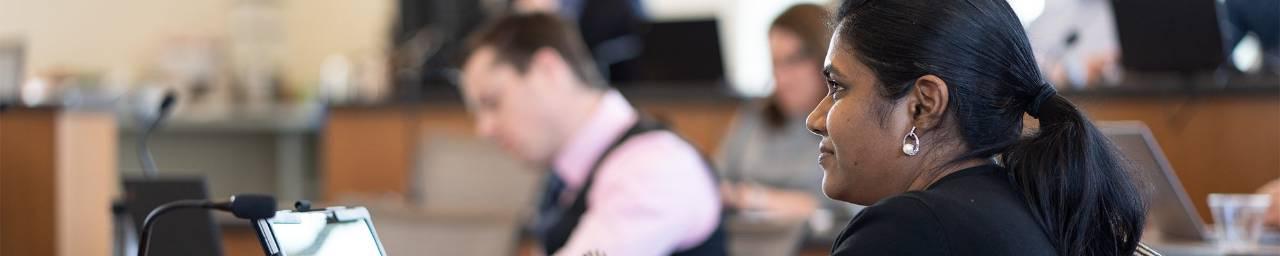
[0,109,119,256]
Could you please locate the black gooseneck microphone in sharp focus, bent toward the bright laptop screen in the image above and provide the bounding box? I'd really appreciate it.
[138,195,275,256]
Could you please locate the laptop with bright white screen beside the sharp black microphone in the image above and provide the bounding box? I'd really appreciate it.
[253,206,387,256]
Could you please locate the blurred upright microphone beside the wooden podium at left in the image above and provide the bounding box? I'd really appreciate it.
[137,90,178,179]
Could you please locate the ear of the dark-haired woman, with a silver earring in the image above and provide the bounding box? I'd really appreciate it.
[908,74,951,131]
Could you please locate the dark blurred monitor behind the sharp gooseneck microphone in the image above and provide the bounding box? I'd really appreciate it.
[124,177,223,256]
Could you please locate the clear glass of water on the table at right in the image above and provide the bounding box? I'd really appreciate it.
[1208,193,1271,253]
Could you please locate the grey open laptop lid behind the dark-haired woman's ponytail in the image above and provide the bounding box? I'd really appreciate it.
[1098,122,1208,241]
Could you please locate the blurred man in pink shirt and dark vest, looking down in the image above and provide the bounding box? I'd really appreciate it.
[462,13,724,256]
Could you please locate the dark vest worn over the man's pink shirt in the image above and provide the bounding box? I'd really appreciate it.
[540,119,727,256]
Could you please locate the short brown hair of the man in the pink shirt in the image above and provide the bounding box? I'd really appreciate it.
[467,13,607,87]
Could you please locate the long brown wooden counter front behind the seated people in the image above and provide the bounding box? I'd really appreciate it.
[323,95,1280,225]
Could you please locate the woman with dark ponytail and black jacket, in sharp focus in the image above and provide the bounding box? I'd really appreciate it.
[808,0,1146,256]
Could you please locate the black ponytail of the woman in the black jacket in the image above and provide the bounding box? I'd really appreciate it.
[1001,92,1146,256]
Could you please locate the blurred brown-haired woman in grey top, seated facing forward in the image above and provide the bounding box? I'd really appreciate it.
[716,4,851,242]
